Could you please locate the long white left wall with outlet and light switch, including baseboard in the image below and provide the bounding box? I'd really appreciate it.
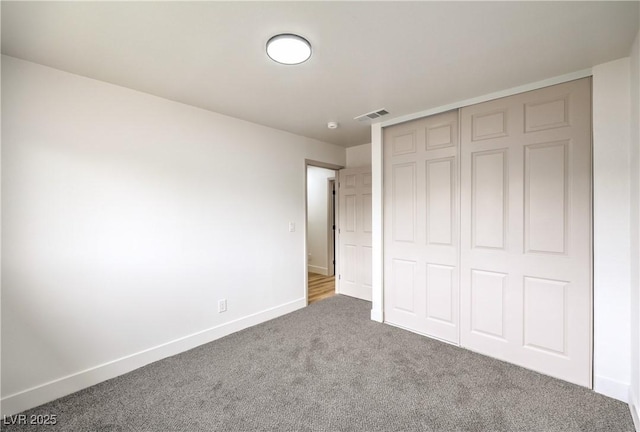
[2,57,345,414]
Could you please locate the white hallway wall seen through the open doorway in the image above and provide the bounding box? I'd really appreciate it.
[307,166,336,276]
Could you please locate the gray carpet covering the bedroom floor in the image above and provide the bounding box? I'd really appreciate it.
[3,296,634,432]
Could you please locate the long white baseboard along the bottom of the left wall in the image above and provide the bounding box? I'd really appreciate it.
[0,298,307,415]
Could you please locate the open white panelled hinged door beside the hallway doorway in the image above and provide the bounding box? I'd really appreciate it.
[337,167,372,301]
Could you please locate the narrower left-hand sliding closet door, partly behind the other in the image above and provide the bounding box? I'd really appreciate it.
[384,111,459,343]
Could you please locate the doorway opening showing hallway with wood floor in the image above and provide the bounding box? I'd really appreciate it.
[306,162,340,304]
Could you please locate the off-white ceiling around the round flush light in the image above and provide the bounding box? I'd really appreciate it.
[1,1,639,147]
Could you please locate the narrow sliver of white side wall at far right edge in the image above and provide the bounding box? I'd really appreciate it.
[629,26,640,429]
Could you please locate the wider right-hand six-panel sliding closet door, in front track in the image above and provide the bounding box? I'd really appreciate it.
[460,79,592,387]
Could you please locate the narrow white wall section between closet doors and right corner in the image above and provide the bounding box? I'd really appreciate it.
[593,58,631,400]
